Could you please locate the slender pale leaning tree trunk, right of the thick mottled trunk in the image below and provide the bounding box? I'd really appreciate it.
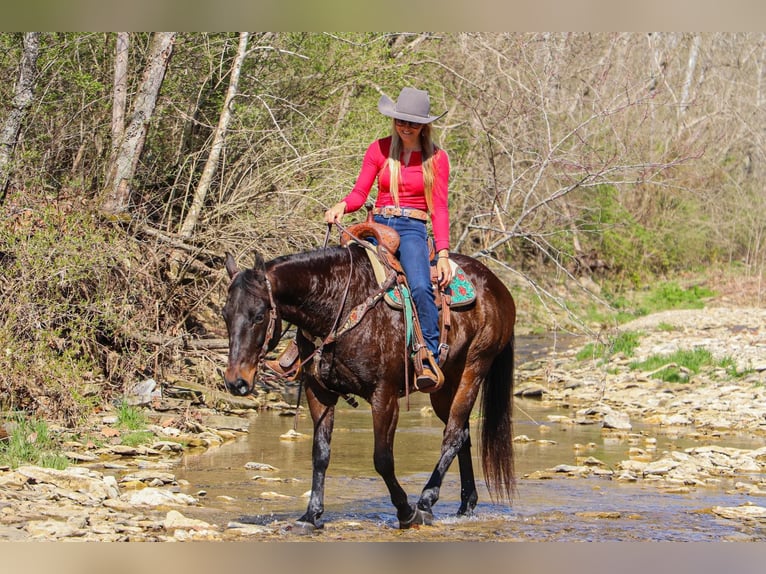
[181,32,249,238]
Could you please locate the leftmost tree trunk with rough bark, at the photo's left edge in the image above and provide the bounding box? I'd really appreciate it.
[0,32,40,205]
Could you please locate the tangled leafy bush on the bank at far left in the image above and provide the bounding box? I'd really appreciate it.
[0,204,152,425]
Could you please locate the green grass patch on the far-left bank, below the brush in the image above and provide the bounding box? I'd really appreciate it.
[0,415,69,470]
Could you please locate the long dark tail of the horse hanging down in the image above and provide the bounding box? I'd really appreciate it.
[480,336,515,500]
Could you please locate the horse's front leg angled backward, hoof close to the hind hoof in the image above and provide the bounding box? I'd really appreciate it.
[371,393,431,529]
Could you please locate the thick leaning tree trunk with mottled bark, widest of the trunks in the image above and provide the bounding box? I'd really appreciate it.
[101,32,177,217]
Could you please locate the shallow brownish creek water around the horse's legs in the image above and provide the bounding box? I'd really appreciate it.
[176,341,764,541]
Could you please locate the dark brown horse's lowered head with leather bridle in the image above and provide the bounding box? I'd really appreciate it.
[223,253,282,396]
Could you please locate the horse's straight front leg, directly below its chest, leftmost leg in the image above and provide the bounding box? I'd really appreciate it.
[298,385,335,530]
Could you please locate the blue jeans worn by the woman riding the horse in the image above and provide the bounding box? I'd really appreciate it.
[375,215,439,359]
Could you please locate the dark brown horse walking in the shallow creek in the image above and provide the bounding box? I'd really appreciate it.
[223,244,516,528]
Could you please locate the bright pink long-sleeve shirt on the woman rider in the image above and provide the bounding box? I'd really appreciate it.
[343,136,450,251]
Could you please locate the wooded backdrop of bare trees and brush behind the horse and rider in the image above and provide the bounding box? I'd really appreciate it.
[0,32,766,425]
